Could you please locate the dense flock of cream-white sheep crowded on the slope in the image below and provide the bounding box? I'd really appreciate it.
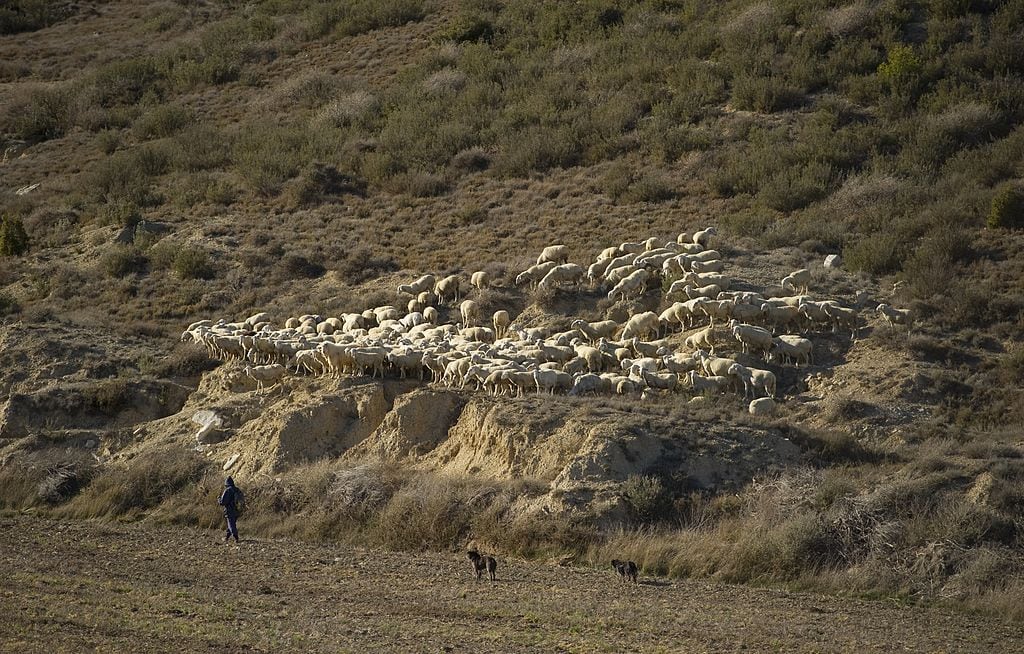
[182,228,908,413]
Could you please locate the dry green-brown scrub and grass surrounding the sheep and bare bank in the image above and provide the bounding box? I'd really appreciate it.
[0,0,1024,630]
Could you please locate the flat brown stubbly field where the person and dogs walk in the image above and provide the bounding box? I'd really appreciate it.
[0,517,1024,653]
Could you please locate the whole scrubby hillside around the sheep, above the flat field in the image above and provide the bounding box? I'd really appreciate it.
[0,0,1024,616]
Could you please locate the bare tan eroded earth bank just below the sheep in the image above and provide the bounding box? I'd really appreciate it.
[94,366,800,512]
